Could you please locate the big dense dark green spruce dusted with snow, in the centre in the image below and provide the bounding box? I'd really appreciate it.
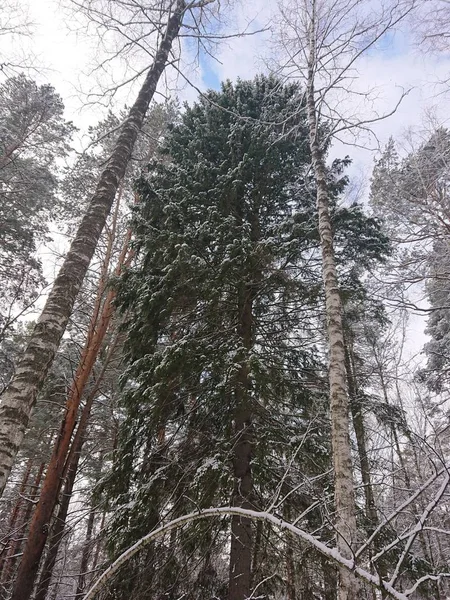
[105,77,386,600]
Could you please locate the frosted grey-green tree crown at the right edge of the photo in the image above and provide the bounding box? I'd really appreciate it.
[371,128,450,391]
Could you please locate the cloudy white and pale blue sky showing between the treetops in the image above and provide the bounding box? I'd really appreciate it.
[4,0,450,356]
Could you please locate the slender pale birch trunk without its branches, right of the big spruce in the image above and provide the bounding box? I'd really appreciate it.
[307,2,360,600]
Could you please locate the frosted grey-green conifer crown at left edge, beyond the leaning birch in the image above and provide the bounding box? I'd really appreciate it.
[0,75,74,339]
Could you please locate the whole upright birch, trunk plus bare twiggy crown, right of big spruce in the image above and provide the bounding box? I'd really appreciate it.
[270,0,414,600]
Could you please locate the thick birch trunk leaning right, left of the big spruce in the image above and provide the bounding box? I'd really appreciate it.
[0,0,186,500]
